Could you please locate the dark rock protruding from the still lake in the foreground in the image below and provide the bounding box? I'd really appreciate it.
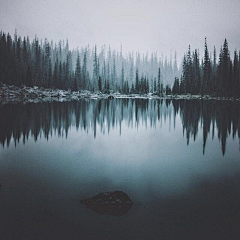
[80,191,133,216]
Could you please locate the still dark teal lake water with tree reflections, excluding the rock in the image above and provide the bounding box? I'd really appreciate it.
[0,99,240,239]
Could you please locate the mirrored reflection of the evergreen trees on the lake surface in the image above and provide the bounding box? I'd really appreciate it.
[0,99,240,155]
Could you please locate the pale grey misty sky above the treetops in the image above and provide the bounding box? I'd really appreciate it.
[0,0,240,62]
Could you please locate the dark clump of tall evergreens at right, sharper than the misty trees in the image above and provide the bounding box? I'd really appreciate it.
[172,38,240,97]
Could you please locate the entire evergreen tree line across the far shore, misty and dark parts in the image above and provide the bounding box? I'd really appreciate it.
[0,31,240,97]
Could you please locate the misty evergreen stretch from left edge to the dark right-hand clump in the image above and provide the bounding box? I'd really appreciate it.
[0,31,180,93]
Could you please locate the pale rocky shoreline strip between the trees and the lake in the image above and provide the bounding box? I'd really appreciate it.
[0,84,240,103]
